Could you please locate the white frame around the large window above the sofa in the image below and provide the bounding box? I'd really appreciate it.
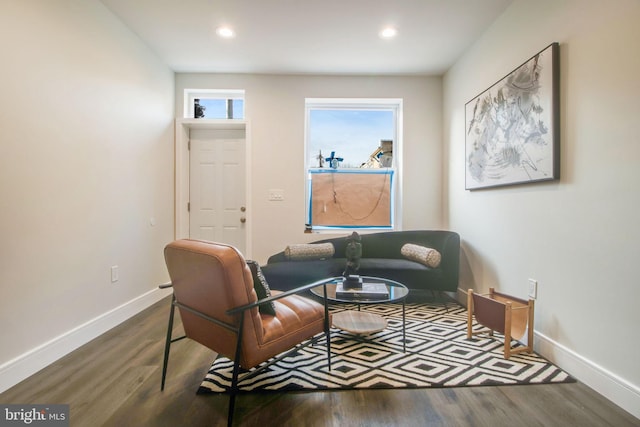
[304,98,403,233]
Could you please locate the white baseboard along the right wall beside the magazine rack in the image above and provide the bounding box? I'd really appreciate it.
[456,288,640,418]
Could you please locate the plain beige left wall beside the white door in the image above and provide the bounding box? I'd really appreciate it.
[0,0,174,390]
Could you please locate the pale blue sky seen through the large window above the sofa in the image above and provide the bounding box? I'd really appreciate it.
[307,109,395,168]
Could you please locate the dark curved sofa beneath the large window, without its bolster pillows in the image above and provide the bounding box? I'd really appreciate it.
[262,230,460,292]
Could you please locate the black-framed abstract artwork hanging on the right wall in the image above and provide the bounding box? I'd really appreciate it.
[465,43,560,190]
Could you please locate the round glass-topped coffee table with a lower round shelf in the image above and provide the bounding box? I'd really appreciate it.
[311,276,409,351]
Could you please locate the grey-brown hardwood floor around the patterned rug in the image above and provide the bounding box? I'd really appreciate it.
[0,299,640,427]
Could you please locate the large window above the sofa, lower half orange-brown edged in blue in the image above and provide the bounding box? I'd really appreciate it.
[305,99,402,231]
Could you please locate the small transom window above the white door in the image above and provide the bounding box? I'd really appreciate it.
[184,89,244,120]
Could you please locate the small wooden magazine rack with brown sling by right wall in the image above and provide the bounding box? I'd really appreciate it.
[467,288,534,359]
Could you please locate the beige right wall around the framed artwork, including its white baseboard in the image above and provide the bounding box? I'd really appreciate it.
[444,0,640,416]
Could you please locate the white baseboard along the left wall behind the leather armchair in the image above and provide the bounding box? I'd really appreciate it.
[0,289,171,393]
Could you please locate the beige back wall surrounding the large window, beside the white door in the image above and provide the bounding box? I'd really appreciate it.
[176,74,442,262]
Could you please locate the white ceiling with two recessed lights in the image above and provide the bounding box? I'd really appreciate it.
[101,0,513,75]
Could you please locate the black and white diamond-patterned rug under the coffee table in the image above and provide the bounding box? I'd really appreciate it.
[198,303,575,393]
